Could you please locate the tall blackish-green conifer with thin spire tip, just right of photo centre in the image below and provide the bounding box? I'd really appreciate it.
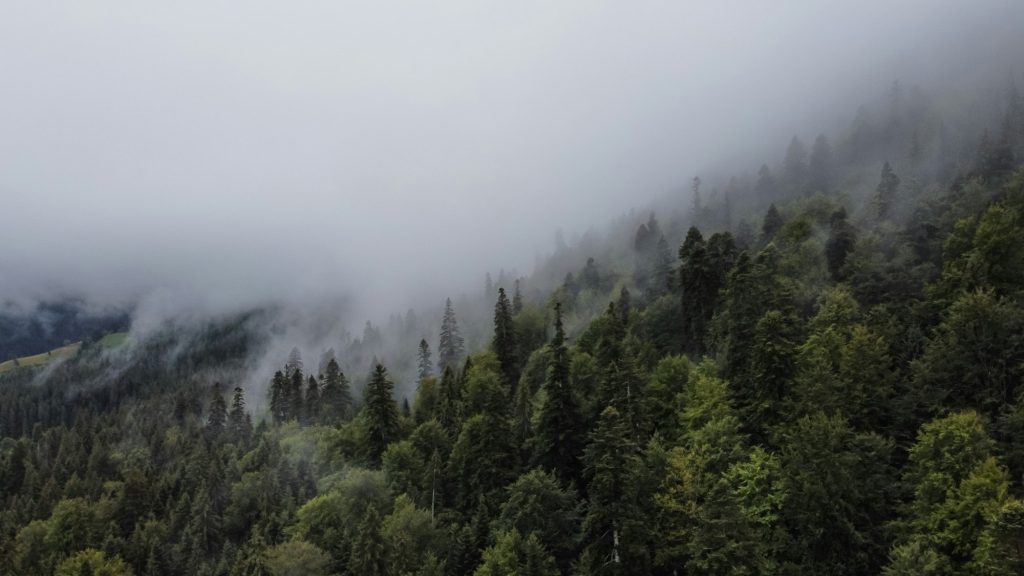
[534,302,585,485]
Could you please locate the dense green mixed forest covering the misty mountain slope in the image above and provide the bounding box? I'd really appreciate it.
[0,81,1024,576]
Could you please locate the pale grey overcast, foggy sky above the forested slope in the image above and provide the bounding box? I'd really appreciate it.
[0,0,1024,317]
